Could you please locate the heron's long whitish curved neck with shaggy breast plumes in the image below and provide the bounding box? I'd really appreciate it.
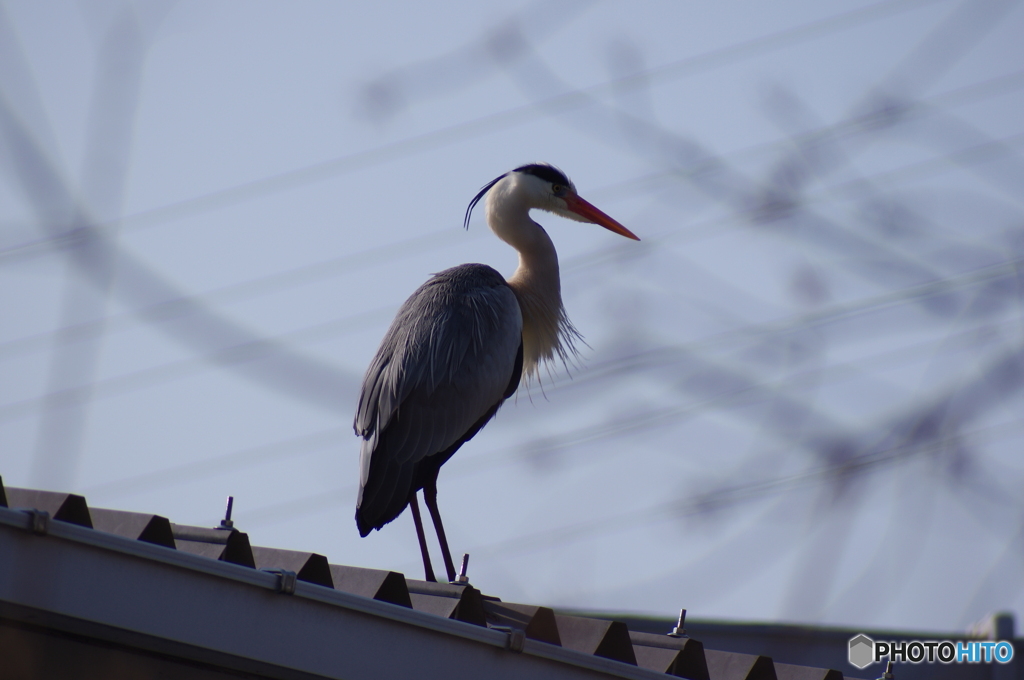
[486,175,580,381]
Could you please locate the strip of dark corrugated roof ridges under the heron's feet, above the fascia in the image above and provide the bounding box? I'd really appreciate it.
[0,478,856,680]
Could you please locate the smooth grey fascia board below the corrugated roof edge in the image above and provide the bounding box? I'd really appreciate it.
[0,508,664,680]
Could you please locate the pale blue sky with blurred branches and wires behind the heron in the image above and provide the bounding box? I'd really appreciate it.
[0,0,1024,631]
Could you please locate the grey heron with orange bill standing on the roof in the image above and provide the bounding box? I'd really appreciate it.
[353,163,639,582]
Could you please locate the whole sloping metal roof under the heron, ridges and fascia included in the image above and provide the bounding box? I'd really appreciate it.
[0,480,843,680]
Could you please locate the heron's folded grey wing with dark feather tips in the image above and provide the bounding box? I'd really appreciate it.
[354,265,522,536]
